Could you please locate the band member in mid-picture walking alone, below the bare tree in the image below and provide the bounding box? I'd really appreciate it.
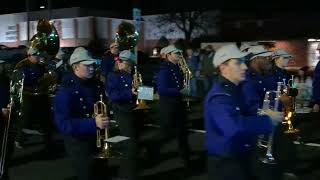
[153,45,190,167]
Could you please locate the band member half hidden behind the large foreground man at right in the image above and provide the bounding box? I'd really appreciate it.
[241,45,294,179]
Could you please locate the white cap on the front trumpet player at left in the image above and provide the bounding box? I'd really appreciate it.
[69,47,96,65]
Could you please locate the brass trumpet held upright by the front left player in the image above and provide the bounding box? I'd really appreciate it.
[94,95,121,159]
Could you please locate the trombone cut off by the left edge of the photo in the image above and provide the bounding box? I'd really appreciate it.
[0,71,24,179]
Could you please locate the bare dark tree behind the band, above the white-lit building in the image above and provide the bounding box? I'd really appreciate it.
[156,11,218,41]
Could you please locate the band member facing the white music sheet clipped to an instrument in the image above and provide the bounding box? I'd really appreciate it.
[106,50,138,180]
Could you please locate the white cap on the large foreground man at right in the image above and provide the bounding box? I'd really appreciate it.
[213,44,249,67]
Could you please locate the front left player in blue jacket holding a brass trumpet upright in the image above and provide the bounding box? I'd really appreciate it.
[54,47,108,180]
